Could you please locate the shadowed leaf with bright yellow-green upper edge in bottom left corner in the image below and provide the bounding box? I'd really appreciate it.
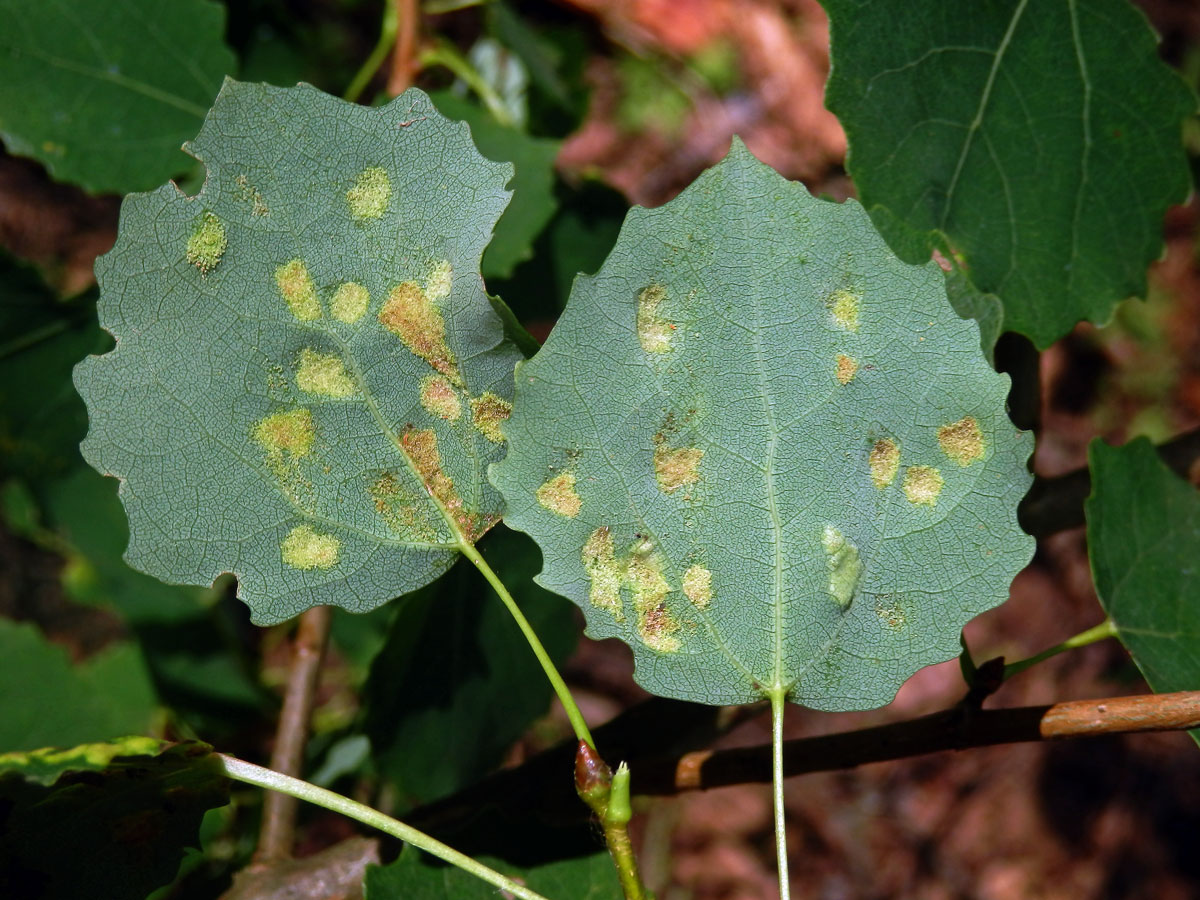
[0,738,229,900]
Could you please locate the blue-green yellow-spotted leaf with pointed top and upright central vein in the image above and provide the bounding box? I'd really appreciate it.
[491,142,1033,709]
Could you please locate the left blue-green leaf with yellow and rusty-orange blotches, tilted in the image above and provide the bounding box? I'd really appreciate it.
[76,82,520,623]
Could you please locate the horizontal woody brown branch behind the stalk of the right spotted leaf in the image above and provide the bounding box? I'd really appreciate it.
[409,691,1200,834]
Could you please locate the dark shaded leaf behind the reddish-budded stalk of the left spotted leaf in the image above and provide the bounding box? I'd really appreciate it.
[364,527,577,805]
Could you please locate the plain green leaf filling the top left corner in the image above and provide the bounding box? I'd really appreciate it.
[0,0,234,192]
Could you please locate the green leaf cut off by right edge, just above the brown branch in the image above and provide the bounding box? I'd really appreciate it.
[1087,439,1200,743]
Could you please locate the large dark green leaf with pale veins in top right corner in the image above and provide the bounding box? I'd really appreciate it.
[824,0,1196,347]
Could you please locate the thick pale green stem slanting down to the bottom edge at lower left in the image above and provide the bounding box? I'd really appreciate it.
[217,754,546,900]
